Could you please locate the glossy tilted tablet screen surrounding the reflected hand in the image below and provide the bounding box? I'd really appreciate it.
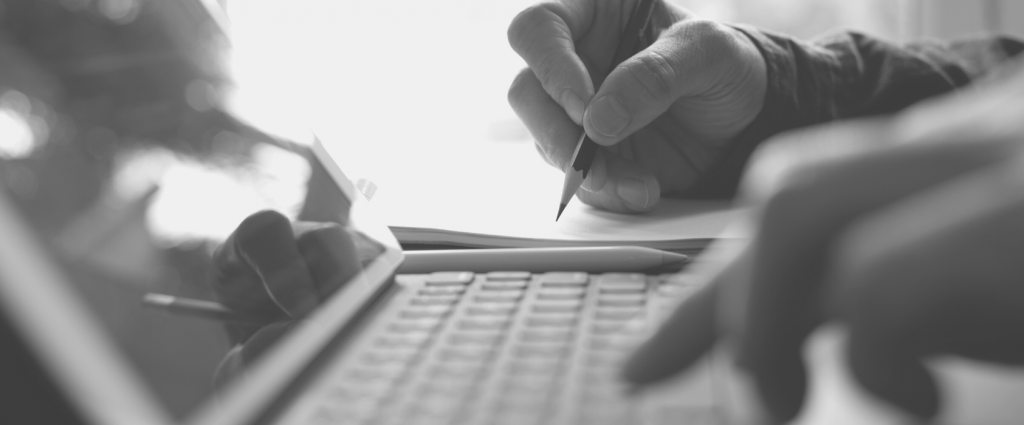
[0,1,391,418]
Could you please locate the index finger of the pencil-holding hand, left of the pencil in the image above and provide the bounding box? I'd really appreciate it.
[508,0,595,124]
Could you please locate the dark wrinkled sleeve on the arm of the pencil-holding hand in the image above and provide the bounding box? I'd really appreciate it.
[687,27,1024,198]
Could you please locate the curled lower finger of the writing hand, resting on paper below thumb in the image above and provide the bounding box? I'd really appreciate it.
[577,147,662,214]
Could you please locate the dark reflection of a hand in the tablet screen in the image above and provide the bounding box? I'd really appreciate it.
[210,211,373,382]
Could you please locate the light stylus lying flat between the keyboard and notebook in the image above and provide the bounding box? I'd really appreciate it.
[398,247,690,273]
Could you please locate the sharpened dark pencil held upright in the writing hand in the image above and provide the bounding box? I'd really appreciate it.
[555,0,654,221]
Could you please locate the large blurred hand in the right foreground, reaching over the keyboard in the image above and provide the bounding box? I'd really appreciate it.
[624,59,1024,422]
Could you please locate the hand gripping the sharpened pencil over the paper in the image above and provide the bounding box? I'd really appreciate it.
[508,0,767,213]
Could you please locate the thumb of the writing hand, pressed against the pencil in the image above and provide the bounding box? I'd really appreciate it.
[583,20,743,145]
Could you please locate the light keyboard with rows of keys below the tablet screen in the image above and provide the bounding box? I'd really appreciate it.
[292,271,719,425]
